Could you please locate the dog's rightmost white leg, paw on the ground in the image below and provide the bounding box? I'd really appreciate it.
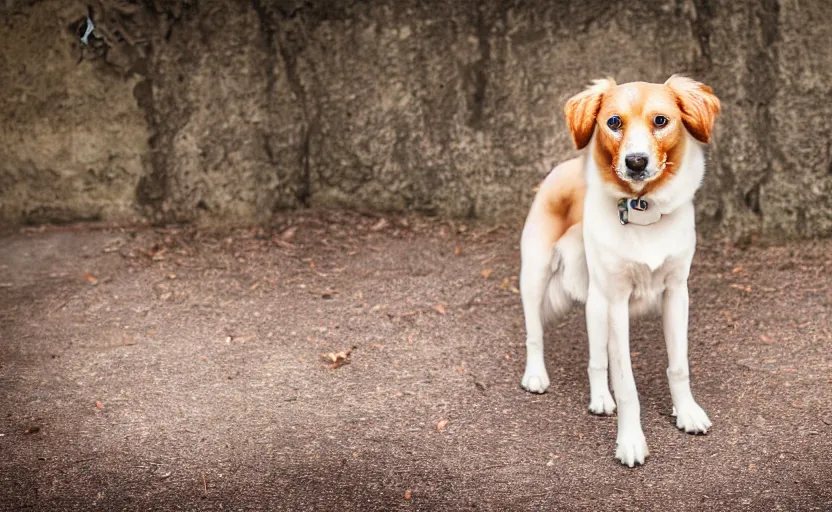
[662,279,711,434]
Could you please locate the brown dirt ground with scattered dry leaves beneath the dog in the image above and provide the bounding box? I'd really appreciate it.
[0,212,832,511]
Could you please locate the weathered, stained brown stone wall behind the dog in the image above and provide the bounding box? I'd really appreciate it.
[0,0,832,237]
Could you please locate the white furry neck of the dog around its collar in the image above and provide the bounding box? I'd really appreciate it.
[584,133,705,220]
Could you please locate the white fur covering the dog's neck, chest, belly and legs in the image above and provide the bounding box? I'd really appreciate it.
[520,133,711,467]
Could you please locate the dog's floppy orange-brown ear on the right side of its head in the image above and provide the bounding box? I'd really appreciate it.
[664,75,721,143]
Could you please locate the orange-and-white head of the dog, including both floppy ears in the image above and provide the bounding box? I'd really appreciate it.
[564,76,720,195]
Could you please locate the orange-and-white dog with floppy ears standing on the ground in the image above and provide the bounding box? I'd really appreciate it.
[520,75,720,467]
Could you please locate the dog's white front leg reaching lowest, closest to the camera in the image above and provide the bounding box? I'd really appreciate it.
[607,293,649,467]
